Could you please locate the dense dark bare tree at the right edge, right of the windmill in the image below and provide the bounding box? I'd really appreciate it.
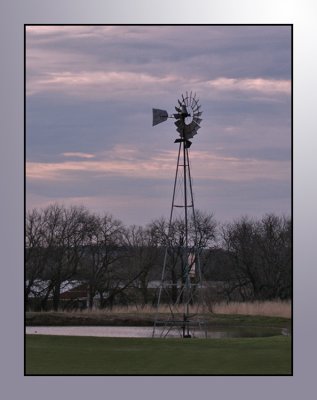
[222,214,292,300]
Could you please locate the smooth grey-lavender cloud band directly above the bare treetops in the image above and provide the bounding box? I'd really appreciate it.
[26,169,291,225]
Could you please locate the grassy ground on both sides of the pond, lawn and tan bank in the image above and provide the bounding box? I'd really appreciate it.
[25,302,292,375]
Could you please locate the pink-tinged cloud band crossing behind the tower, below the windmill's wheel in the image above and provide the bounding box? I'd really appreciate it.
[26,146,289,182]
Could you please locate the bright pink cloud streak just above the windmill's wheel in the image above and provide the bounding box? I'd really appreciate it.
[27,66,291,99]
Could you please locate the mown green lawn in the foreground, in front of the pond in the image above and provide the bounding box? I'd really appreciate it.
[25,335,292,375]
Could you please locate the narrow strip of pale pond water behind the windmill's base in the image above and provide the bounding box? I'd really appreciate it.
[26,326,289,339]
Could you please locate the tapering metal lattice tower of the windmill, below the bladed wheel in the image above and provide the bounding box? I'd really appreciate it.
[152,140,203,338]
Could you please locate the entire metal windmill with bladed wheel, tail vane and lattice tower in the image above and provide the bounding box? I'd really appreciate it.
[152,92,206,338]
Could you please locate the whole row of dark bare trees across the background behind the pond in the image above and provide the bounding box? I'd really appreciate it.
[25,204,292,310]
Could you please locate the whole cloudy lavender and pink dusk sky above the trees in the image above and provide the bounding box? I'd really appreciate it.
[25,25,292,225]
